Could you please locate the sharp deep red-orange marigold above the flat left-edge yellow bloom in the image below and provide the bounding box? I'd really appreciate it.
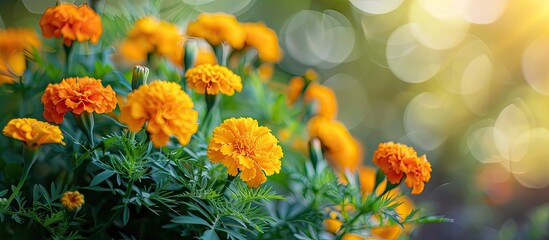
[42,77,117,124]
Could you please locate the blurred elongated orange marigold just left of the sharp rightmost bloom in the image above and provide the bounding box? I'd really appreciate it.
[307,116,362,171]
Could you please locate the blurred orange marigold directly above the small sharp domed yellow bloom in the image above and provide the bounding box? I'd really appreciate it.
[187,13,246,49]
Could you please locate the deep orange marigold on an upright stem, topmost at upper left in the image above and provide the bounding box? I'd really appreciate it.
[40,3,103,46]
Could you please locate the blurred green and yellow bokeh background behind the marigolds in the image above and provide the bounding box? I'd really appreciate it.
[0,0,549,239]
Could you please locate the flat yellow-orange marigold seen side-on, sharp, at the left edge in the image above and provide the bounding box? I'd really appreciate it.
[2,118,65,147]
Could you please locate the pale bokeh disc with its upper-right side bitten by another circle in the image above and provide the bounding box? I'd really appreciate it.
[386,23,444,83]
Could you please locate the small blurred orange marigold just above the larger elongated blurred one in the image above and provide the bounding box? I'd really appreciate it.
[303,83,337,118]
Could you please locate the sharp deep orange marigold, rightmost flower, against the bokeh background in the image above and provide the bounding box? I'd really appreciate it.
[372,142,432,194]
